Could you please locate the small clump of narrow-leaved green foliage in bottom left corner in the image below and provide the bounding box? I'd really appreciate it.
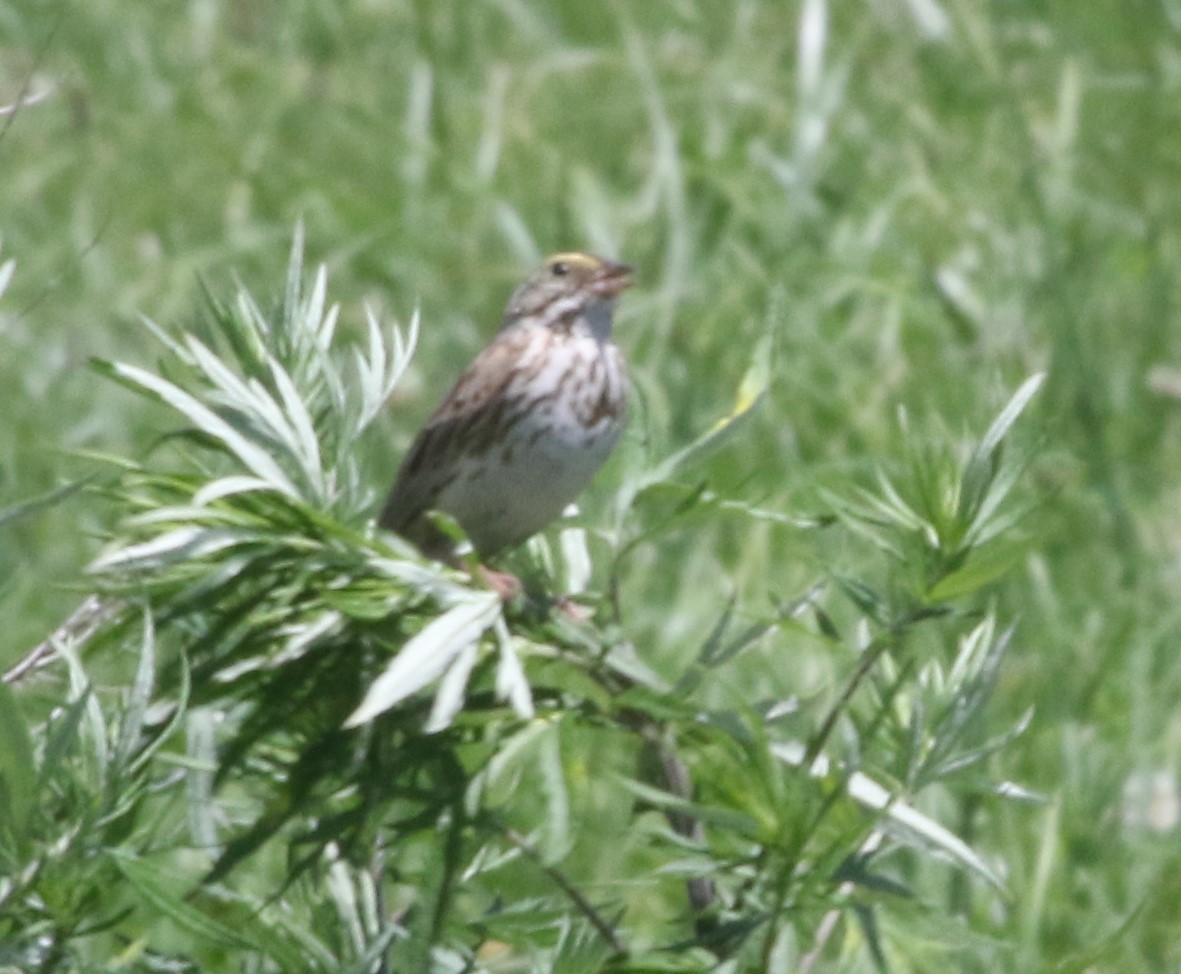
[0,619,185,970]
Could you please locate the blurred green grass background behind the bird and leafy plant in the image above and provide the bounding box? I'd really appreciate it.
[0,0,1181,970]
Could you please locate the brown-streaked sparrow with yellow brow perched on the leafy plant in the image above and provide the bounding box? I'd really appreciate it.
[379,253,634,562]
